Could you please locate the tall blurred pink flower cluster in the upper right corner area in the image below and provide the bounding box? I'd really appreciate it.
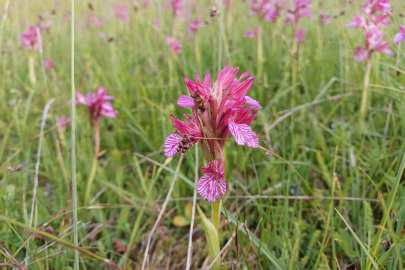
[346,0,394,62]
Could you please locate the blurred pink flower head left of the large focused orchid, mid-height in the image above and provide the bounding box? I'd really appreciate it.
[69,86,117,123]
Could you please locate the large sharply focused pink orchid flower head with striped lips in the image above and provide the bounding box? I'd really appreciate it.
[164,63,261,203]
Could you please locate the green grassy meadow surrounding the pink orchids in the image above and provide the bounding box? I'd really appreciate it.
[0,0,405,270]
